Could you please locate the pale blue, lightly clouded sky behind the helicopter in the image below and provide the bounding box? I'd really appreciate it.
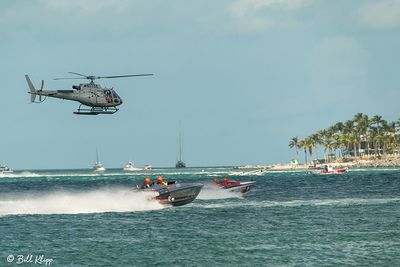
[0,0,400,169]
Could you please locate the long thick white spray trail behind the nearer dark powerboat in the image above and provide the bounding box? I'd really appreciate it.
[0,189,164,216]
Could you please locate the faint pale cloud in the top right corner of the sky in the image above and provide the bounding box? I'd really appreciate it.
[358,0,400,29]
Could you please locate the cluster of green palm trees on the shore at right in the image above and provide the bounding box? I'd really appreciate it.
[289,113,400,163]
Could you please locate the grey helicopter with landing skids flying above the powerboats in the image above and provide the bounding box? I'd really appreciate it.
[25,72,153,115]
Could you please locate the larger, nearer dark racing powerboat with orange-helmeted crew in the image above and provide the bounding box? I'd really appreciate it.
[138,181,203,206]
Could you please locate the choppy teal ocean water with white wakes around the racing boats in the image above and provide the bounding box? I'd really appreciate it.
[0,168,400,266]
